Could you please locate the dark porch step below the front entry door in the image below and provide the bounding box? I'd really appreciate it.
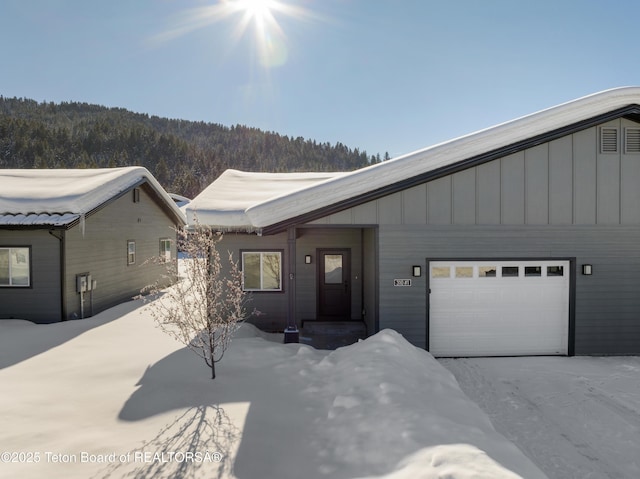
[300,320,367,349]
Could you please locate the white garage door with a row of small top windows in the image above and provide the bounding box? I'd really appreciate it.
[429,260,569,356]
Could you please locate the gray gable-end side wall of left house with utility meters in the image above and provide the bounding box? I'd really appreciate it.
[65,185,176,319]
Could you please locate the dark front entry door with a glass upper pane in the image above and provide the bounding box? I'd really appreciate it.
[317,249,351,320]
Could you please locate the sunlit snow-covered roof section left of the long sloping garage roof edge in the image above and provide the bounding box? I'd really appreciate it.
[184,170,347,231]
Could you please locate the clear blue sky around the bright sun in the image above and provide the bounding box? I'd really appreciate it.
[0,0,640,156]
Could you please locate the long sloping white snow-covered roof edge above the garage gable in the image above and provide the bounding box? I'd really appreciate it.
[246,87,640,228]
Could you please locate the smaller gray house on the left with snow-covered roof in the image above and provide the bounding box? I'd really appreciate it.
[0,167,185,323]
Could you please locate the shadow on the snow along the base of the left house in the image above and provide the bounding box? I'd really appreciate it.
[0,301,144,369]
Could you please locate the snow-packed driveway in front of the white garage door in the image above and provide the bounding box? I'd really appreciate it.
[439,357,640,479]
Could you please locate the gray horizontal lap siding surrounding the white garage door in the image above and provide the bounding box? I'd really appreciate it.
[379,225,640,354]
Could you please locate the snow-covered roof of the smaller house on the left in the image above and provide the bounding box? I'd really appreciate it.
[0,166,185,226]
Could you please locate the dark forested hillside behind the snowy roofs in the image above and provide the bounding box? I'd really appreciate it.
[0,96,388,198]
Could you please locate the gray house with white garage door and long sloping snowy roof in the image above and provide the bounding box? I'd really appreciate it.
[186,87,640,356]
